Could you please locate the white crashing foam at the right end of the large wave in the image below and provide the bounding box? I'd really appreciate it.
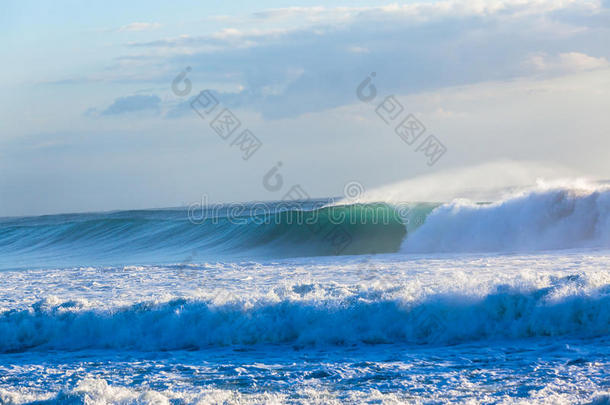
[401,187,610,253]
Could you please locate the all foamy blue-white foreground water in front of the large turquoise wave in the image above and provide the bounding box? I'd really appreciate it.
[0,230,610,404]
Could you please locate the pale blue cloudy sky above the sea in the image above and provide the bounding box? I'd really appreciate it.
[0,0,610,215]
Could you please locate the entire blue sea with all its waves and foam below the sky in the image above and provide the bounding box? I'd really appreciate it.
[0,185,610,404]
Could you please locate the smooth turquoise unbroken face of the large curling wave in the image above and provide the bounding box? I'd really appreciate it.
[0,201,434,269]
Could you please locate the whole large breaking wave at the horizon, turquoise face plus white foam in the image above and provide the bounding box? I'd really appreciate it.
[0,183,610,269]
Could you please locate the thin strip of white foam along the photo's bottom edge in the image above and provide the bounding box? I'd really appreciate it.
[0,378,610,405]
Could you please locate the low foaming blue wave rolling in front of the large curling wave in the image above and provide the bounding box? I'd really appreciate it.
[0,276,610,353]
